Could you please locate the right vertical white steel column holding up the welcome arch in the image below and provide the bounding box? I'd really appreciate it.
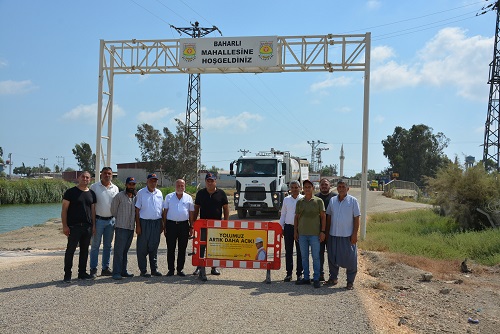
[361,32,371,240]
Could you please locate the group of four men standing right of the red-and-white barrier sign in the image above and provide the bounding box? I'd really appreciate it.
[280,178,360,290]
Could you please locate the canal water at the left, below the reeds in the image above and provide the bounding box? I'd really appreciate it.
[0,203,62,233]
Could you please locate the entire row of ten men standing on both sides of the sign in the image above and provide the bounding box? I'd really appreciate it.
[61,167,360,290]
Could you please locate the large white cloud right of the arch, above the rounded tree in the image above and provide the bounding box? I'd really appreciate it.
[371,28,493,101]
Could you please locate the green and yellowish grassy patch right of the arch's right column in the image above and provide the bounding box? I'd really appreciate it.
[359,210,500,266]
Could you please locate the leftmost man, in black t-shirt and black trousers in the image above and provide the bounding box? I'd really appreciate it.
[61,172,97,283]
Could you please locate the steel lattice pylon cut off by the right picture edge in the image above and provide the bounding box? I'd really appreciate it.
[476,1,500,171]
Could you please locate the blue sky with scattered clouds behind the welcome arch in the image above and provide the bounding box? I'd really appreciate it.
[0,0,495,176]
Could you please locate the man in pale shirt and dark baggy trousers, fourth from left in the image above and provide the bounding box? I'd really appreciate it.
[135,174,163,277]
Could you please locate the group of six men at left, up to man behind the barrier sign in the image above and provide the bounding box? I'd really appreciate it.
[61,167,229,283]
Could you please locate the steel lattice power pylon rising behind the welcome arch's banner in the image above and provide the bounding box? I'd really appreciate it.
[170,21,222,183]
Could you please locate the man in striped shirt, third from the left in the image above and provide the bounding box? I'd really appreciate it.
[111,177,136,280]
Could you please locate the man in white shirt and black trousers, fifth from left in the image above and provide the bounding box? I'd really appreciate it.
[163,179,194,277]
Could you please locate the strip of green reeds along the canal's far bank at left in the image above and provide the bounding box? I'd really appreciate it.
[0,179,74,204]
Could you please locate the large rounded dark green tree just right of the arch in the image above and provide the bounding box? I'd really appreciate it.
[382,124,449,184]
